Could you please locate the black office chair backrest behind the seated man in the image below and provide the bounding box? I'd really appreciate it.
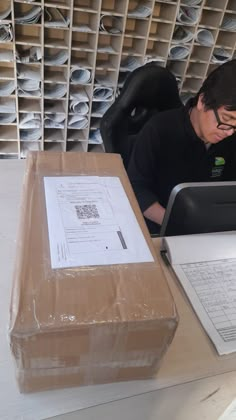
[100,62,182,168]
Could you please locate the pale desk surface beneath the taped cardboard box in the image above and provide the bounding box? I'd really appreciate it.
[0,161,236,420]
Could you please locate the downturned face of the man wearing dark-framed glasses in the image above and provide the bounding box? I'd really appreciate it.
[197,97,236,144]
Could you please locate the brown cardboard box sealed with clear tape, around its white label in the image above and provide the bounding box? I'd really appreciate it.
[10,152,178,392]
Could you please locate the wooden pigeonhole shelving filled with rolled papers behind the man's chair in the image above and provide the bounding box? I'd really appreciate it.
[0,0,236,158]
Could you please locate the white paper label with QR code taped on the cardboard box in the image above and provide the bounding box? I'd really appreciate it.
[44,176,153,268]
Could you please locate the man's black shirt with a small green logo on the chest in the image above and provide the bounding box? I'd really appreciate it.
[128,107,236,230]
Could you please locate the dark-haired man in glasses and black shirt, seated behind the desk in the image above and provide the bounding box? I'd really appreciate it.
[128,60,236,233]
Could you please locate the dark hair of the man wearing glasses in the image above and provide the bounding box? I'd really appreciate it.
[192,60,236,111]
